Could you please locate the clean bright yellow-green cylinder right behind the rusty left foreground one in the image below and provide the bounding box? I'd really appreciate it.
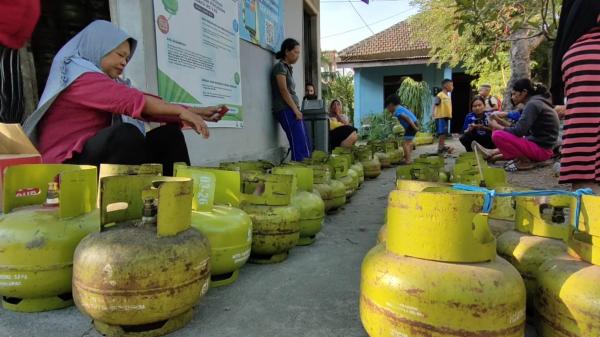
[174,165,252,288]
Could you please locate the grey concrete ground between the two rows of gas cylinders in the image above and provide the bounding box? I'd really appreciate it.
[0,140,535,337]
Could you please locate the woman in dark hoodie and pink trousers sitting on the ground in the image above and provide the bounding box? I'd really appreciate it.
[473,79,559,172]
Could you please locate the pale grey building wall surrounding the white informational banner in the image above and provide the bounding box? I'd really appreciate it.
[110,0,314,166]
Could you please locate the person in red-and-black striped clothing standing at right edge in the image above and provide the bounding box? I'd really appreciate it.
[552,0,600,193]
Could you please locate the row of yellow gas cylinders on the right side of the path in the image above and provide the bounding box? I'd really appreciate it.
[368,154,600,337]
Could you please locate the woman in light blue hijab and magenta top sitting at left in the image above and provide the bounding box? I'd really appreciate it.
[24,20,221,175]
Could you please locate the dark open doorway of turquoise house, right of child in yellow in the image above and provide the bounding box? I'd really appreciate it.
[450,73,477,133]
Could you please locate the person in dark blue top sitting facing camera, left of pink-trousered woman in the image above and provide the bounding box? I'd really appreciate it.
[460,96,496,152]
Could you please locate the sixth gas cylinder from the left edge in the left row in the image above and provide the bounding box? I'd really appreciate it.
[309,164,346,212]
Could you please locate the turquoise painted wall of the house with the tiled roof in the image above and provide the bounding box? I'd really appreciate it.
[354,64,452,127]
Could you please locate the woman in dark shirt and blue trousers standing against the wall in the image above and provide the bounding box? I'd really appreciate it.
[271,39,310,161]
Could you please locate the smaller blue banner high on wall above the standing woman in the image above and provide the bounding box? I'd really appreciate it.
[239,0,284,52]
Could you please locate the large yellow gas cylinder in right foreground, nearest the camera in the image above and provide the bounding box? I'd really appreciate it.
[360,190,525,337]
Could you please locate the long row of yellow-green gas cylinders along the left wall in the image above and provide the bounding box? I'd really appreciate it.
[0,144,390,336]
